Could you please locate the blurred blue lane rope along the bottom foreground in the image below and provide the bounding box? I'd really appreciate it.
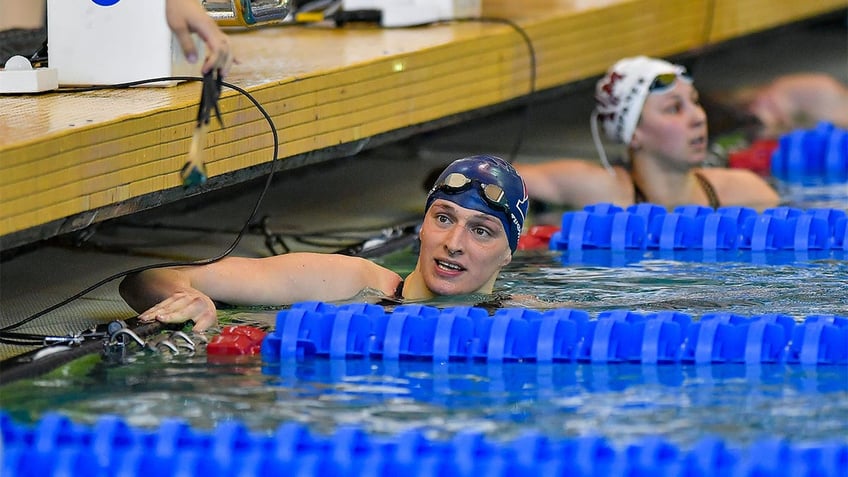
[0,413,848,477]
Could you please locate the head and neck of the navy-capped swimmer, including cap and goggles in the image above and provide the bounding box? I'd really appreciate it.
[412,156,527,297]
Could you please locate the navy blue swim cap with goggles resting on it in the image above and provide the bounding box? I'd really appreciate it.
[424,155,528,253]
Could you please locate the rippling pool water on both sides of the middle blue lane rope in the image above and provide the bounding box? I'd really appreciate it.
[2,245,848,449]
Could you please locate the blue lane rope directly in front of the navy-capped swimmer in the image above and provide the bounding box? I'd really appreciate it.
[261,302,848,365]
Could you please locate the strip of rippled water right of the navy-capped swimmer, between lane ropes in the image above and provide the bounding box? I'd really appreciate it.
[500,250,848,318]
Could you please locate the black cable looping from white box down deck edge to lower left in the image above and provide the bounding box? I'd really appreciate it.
[0,76,279,336]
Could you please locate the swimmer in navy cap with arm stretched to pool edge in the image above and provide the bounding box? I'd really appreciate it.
[120,156,528,331]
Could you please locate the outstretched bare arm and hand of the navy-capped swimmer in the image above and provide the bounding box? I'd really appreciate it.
[120,252,401,331]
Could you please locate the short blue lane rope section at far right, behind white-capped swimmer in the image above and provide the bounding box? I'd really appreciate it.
[771,122,848,184]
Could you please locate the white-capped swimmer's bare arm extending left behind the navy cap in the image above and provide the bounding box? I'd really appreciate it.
[513,159,625,207]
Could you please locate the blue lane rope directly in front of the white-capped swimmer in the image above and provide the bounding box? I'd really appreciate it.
[549,203,848,253]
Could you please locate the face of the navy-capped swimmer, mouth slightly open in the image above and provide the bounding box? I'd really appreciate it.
[416,199,512,295]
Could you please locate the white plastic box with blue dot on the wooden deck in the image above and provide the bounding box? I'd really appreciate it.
[47,0,205,85]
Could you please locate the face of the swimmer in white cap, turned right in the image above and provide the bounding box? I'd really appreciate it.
[630,81,707,168]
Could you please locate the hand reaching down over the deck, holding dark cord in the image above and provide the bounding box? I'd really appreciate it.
[165,0,235,77]
